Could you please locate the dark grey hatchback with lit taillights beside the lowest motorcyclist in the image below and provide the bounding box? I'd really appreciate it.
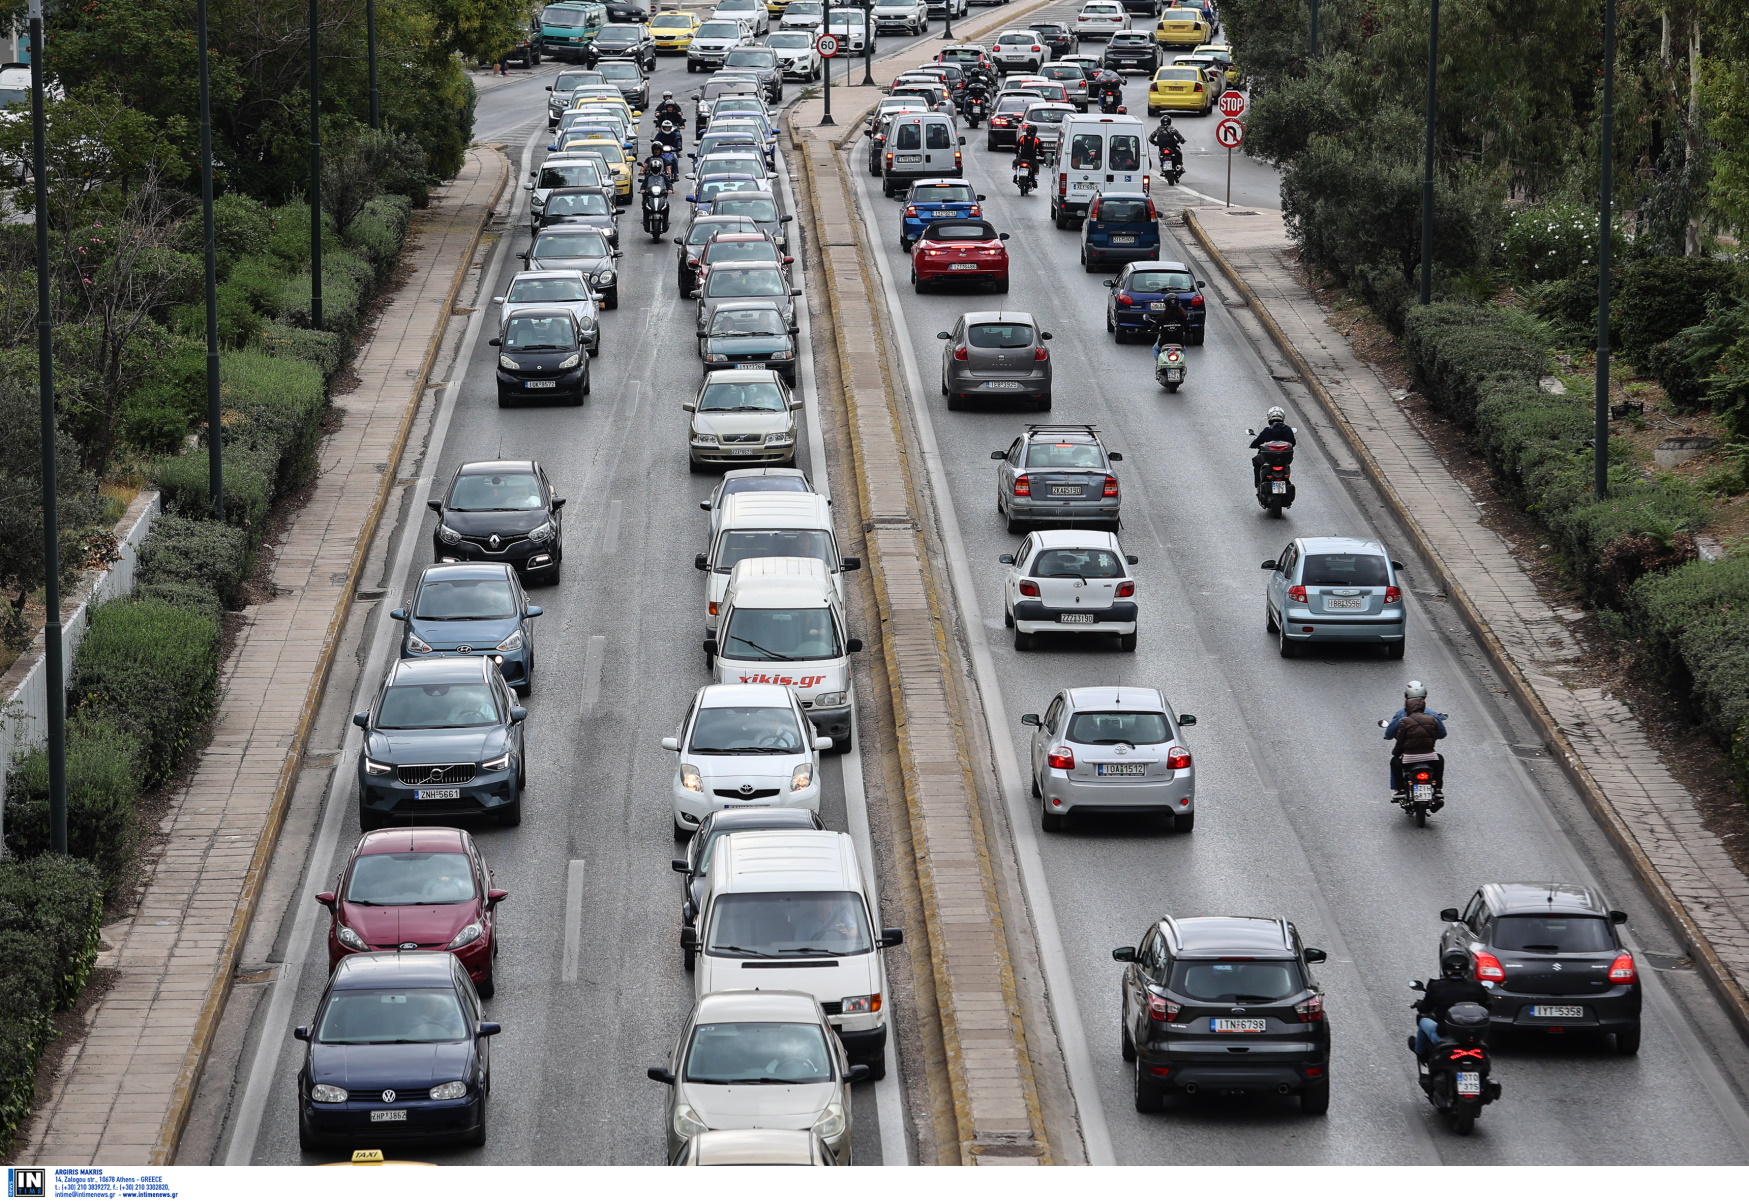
[1439,883,1641,1054]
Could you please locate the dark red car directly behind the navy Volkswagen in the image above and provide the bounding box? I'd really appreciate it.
[317,827,509,996]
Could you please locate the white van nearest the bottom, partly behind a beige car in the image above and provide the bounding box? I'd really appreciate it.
[680,830,904,1080]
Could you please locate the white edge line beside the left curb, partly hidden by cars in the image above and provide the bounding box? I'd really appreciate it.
[224,117,535,1166]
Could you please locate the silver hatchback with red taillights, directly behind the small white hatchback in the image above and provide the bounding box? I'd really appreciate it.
[1020,685,1196,834]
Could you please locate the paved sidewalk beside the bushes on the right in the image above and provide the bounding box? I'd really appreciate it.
[1184,206,1749,1033]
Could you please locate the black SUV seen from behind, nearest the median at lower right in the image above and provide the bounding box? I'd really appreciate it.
[1111,918,1329,1114]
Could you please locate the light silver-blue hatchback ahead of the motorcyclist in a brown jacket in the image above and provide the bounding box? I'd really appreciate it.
[1263,538,1408,659]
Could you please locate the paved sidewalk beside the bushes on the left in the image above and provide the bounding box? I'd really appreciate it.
[19,147,509,1164]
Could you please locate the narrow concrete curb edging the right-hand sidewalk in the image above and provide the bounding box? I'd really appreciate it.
[1184,208,1749,1038]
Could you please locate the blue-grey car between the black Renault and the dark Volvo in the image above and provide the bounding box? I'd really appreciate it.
[388,563,540,696]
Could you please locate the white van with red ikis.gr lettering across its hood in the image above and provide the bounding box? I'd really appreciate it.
[705,558,862,753]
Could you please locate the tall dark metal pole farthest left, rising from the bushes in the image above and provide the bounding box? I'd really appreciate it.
[30,0,66,855]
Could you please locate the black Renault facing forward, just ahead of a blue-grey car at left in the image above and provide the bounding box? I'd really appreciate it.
[427,458,565,584]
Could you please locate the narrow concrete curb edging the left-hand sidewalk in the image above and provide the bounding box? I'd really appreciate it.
[150,154,511,1164]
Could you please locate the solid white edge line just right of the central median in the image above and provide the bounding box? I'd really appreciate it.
[852,150,1118,1164]
